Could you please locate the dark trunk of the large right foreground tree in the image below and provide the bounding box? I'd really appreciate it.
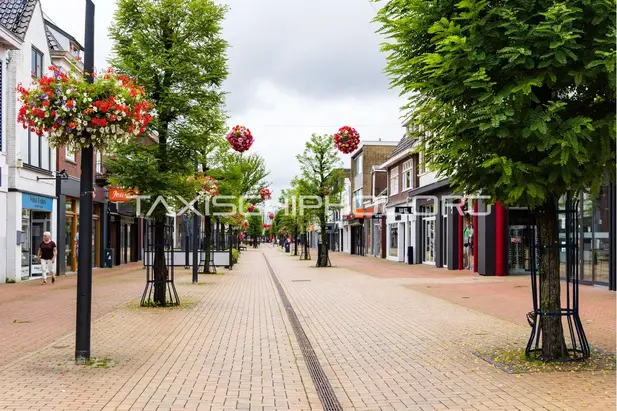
[537,198,568,361]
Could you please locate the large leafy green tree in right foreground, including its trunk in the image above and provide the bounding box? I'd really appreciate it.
[376,0,616,360]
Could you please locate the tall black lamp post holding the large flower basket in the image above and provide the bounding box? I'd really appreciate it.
[75,0,94,364]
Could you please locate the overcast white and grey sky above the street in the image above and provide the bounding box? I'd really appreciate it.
[41,0,403,208]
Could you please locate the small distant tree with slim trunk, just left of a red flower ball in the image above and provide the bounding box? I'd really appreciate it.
[295,134,344,267]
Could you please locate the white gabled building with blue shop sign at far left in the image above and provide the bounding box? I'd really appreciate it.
[0,0,58,282]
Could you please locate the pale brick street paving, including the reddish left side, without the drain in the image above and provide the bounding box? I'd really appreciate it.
[0,245,615,410]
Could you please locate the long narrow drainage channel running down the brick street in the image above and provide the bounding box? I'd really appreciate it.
[263,254,343,411]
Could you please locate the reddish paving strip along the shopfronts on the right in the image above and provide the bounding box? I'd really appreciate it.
[312,250,617,353]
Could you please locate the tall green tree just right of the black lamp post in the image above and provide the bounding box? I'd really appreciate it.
[110,0,227,305]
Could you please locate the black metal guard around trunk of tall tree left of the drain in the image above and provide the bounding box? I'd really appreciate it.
[141,220,180,307]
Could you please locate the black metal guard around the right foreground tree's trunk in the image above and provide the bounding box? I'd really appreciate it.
[525,193,590,360]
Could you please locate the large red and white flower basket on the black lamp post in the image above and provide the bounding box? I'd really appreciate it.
[17,66,154,151]
